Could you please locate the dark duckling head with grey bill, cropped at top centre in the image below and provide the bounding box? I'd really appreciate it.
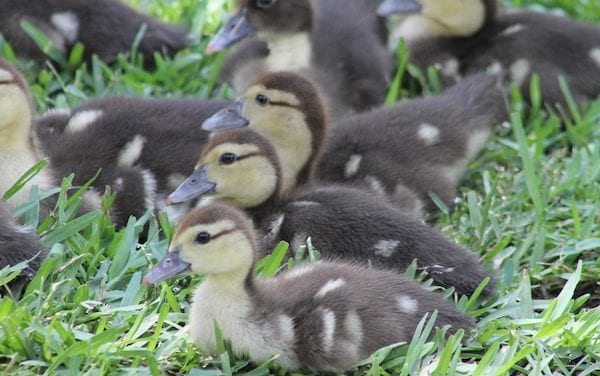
[206,0,312,53]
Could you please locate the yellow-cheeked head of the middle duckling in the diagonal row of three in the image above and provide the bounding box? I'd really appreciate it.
[167,129,280,209]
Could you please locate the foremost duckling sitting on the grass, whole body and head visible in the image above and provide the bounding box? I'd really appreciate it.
[144,204,474,372]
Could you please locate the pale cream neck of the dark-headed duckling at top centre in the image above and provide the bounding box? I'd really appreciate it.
[264,32,312,71]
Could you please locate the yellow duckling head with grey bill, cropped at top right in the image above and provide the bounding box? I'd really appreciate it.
[377,0,486,37]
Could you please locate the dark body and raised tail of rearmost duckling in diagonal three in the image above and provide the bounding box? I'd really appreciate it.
[315,74,507,211]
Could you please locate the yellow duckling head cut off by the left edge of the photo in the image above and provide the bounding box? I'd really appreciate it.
[0,59,32,149]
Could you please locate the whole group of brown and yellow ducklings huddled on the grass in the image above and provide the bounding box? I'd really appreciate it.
[0,0,600,372]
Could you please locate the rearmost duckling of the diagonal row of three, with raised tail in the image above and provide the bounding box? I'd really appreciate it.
[203,73,507,216]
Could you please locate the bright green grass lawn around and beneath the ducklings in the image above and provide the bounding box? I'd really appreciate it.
[0,0,600,376]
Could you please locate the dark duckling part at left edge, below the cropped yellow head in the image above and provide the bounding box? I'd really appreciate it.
[0,200,45,277]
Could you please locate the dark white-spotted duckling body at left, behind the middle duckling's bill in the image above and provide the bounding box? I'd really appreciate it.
[35,97,231,223]
